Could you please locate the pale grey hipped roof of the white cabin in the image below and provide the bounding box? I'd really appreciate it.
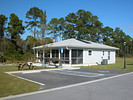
[33,38,119,50]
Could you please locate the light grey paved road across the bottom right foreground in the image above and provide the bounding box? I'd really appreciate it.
[3,72,133,100]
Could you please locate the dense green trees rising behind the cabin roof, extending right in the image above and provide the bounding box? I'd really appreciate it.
[48,9,133,57]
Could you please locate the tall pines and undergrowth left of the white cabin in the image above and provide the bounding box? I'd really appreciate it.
[0,7,53,62]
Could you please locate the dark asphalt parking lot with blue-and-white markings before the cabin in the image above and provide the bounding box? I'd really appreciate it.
[12,68,128,90]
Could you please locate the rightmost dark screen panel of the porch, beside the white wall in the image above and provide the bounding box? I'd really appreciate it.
[72,49,83,64]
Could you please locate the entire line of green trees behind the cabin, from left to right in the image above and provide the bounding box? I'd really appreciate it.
[0,7,133,61]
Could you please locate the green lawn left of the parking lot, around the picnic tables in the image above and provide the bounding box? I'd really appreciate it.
[0,66,55,97]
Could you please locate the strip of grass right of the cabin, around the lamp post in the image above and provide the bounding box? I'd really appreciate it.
[81,57,133,71]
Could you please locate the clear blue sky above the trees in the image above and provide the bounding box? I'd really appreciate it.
[0,0,133,39]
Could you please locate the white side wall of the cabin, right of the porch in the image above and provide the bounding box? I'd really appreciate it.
[83,49,115,65]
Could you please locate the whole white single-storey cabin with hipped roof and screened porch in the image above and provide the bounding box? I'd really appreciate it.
[30,38,119,67]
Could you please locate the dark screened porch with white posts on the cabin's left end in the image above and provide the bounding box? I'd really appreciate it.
[30,48,83,65]
